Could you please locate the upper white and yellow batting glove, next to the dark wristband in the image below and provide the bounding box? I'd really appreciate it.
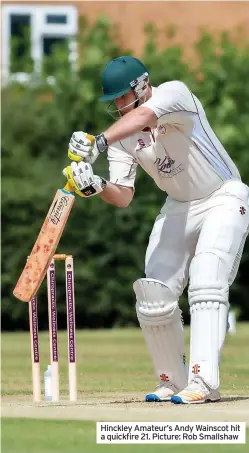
[68,131,99,164]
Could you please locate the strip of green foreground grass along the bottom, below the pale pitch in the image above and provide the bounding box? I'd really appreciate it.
[2,418,249,453]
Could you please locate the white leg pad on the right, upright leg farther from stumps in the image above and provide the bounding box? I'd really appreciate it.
[189,253,229,389]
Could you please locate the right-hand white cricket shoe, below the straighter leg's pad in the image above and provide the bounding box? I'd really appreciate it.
[171,376,220,404]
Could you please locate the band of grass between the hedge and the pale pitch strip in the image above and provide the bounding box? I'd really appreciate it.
[2,323,249,397]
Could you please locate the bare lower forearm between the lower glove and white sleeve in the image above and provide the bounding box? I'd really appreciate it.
[99,181,134,208]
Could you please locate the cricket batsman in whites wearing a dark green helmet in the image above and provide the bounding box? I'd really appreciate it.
[63,56,249,404]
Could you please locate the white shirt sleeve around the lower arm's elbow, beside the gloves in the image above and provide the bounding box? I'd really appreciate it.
[107,142,137,187]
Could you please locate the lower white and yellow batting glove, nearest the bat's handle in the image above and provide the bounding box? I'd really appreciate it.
[63,162,106,198]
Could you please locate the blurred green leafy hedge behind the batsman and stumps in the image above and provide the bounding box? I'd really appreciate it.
[2,19,249,329]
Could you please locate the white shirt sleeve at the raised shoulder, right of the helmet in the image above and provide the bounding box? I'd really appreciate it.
[143,81,197,124]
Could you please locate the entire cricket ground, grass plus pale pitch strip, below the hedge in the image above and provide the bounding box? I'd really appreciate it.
[2,324,249,453]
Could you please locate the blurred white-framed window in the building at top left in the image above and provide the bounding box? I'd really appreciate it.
[2,4,78,79]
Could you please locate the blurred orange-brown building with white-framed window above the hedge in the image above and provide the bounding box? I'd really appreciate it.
[1,0,249,77]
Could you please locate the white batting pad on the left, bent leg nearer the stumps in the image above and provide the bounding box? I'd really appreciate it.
[133,278,187,390]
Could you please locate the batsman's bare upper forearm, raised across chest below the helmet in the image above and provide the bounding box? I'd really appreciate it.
[104,107,157,145]
